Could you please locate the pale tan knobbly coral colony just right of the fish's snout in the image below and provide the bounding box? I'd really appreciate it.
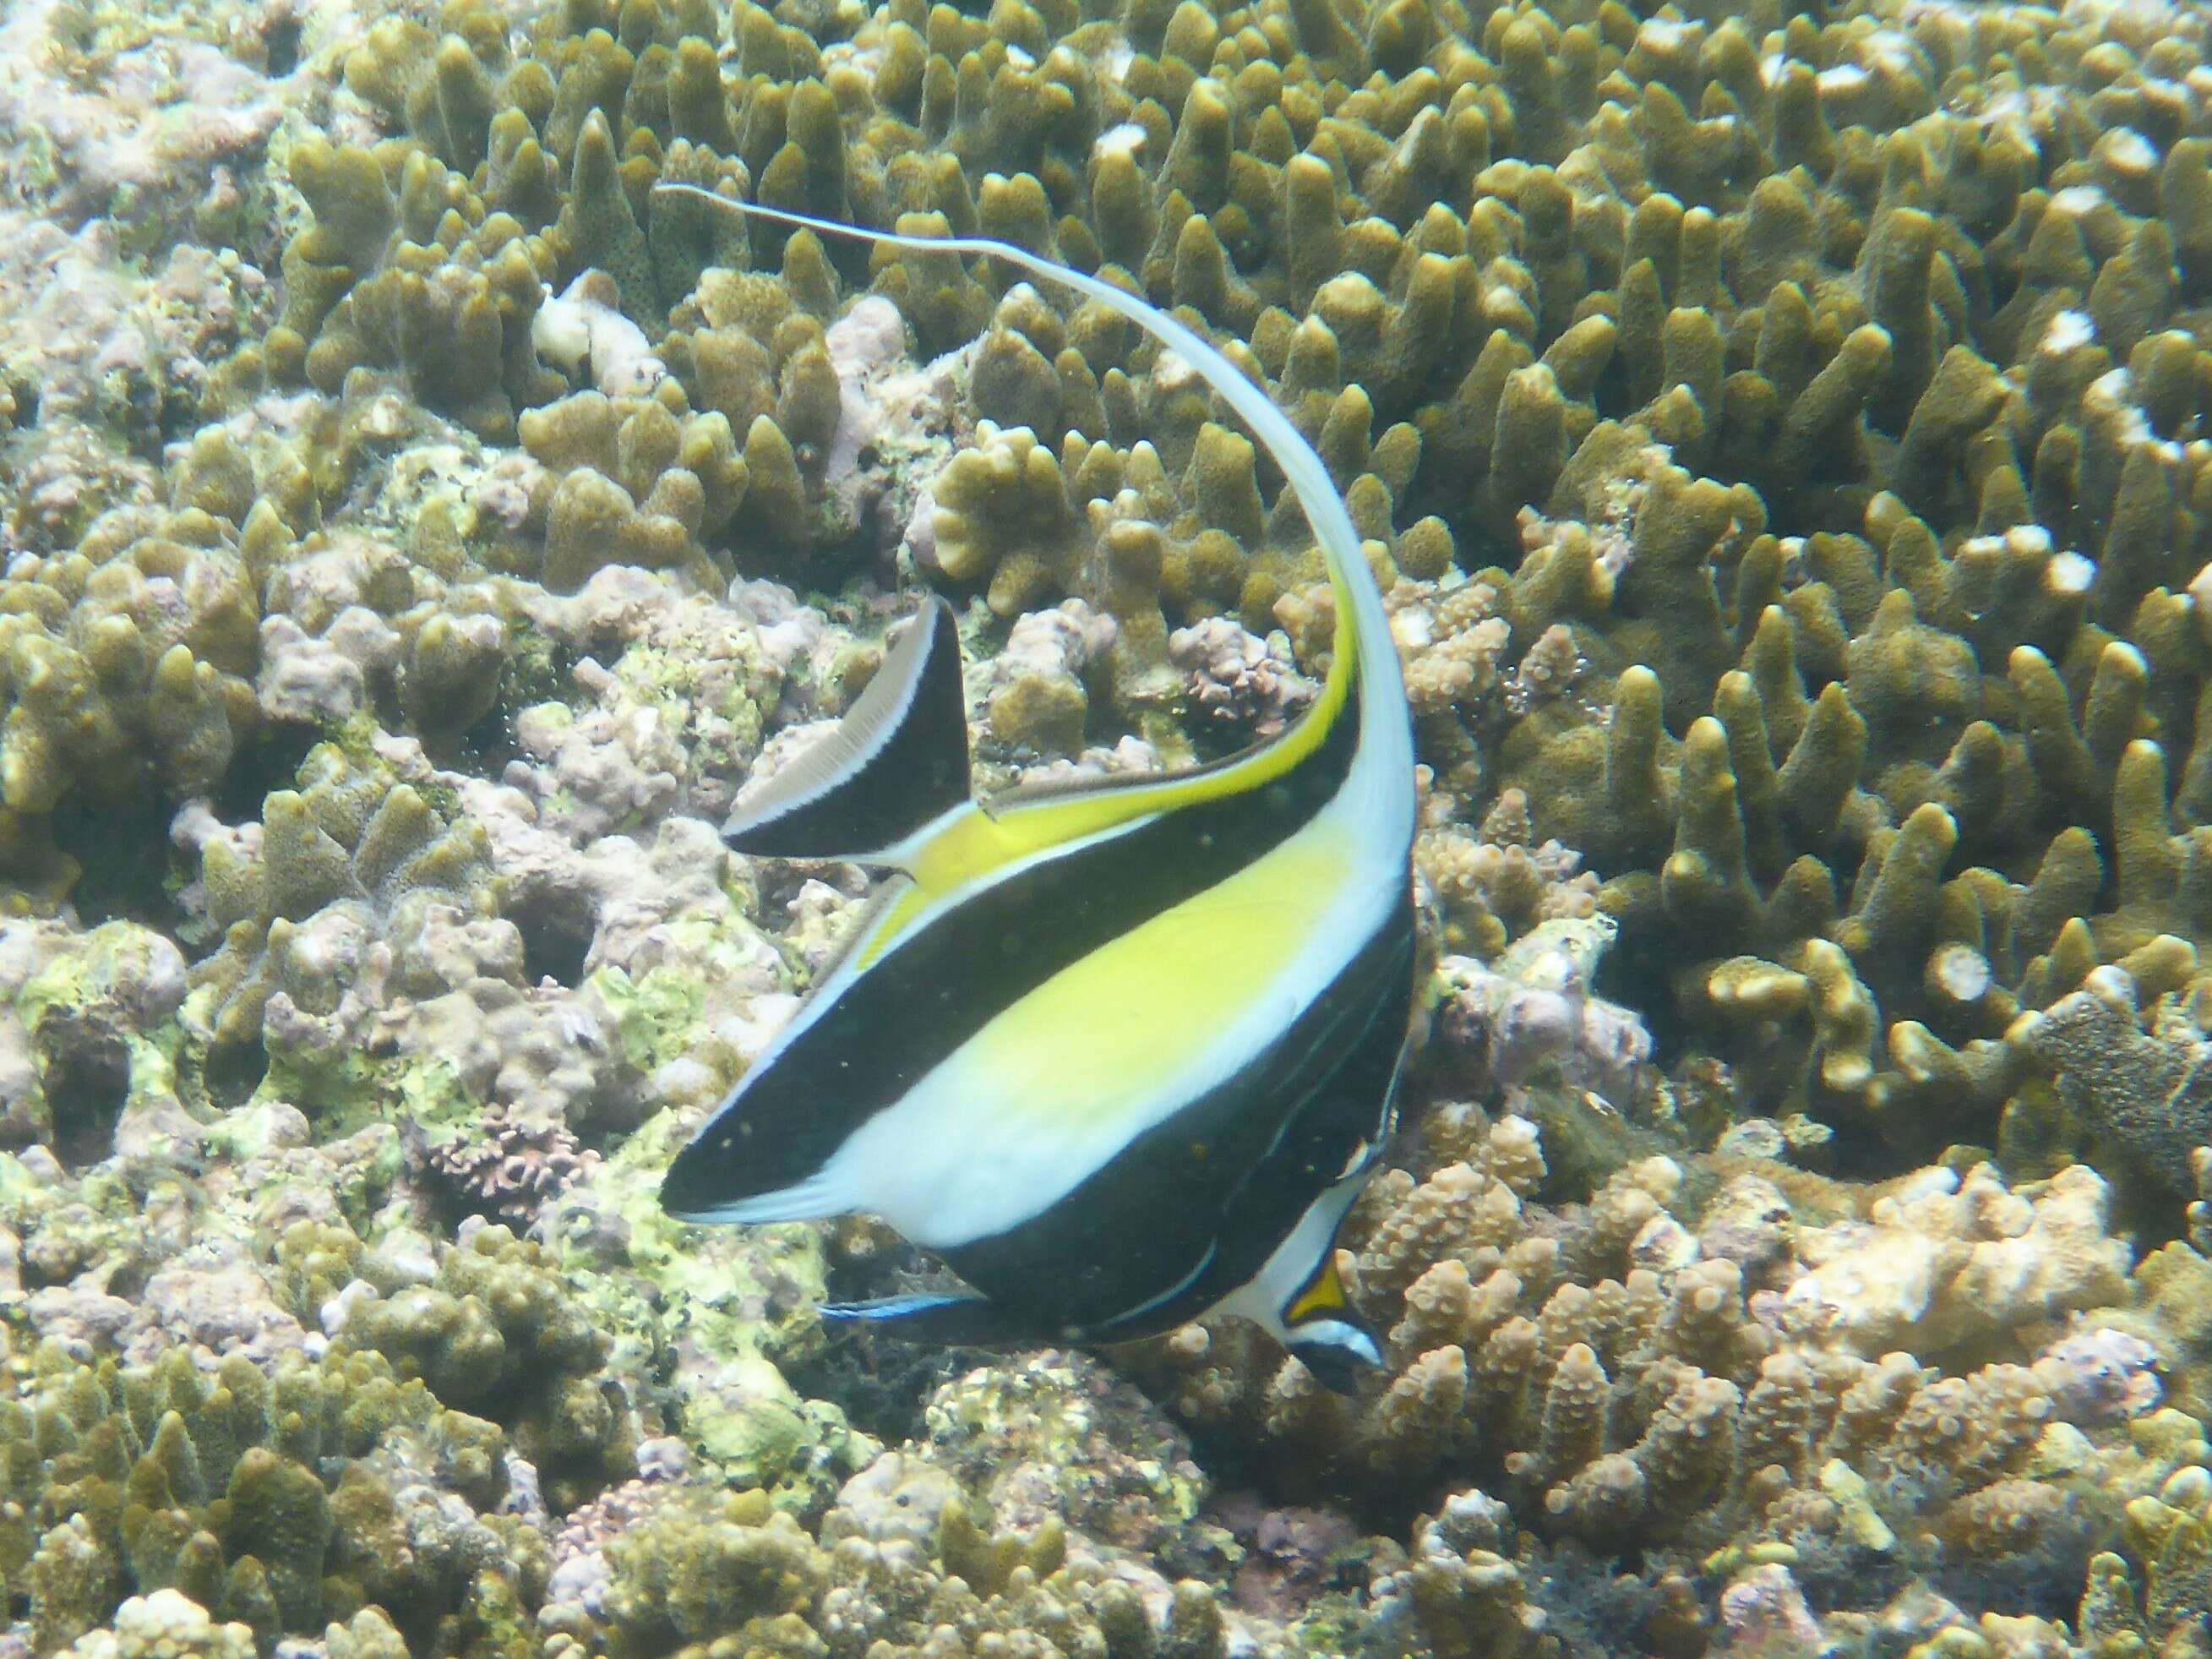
[1123,1113,2181,1636]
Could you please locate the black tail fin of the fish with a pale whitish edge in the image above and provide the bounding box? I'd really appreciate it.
[721,599,969,865]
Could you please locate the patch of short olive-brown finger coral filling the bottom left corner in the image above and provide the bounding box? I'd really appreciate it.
[0,1327,561,1655]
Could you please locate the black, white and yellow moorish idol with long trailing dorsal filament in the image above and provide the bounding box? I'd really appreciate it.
[659,186,1414,1387]
